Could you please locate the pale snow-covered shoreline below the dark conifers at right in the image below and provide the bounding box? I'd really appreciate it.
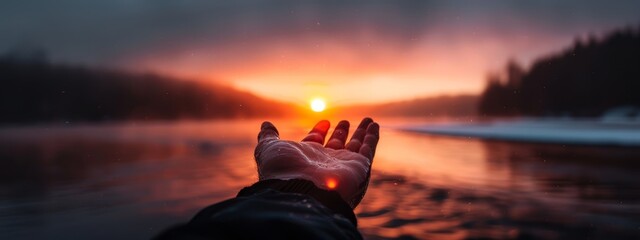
[397,119,640,147]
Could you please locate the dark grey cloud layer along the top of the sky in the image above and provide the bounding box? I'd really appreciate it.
[0,0,640,68]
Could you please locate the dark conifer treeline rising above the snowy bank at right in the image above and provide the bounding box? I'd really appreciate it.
[479,25,640,117]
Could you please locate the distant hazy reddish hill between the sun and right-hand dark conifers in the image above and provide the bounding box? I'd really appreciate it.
[333,95,478,117]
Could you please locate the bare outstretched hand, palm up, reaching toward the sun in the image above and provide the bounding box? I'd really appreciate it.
[255,118,380,208]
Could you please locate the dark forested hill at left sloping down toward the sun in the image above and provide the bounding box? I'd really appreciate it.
[0,57,290,124]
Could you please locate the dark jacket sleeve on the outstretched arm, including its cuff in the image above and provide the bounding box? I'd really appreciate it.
[156,180,362,239]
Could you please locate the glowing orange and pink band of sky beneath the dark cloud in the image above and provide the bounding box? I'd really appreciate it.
[135,27,572,106]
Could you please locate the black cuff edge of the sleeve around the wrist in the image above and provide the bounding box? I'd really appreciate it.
[238,179,358,227]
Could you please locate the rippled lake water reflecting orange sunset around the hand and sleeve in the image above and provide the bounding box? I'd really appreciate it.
[0,119,640,239]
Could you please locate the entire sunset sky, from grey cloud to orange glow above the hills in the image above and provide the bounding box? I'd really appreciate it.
[0,0,640,105]
